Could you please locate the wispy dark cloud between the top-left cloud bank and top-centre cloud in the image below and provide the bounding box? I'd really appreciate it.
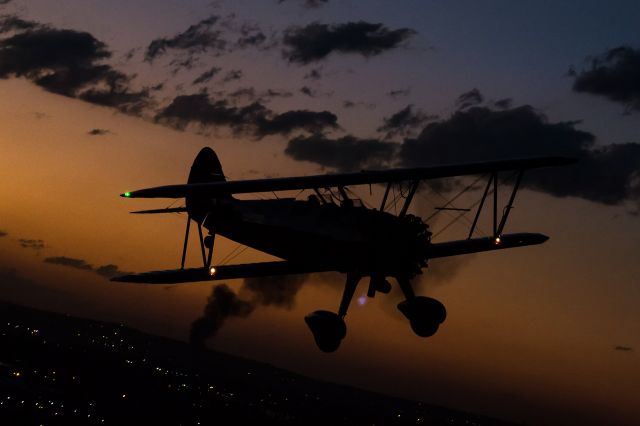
[145,15,227,62]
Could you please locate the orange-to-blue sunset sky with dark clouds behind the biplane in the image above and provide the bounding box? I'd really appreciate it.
[0,0,640,425]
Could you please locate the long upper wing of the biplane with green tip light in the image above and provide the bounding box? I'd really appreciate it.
[121,157,575,198]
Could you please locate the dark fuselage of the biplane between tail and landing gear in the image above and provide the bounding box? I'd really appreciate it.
[198,197,430,276]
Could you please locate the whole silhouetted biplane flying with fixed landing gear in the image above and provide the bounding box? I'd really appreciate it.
[113,147,574,352]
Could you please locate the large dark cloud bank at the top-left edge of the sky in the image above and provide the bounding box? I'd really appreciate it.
[0,23,149,114]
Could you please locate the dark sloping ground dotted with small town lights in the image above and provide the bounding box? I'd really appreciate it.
[0,302,511,426]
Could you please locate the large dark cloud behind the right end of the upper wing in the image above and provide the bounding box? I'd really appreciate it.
[399,106,640,204]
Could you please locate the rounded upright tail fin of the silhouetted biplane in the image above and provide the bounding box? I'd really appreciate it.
[185,147,226,222]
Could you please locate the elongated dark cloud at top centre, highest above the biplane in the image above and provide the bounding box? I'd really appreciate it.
[283,21,415,64]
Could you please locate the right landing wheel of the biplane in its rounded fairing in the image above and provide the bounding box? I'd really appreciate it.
[398,296,447,337]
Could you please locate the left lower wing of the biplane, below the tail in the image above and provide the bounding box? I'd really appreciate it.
[111,261,335,284]
